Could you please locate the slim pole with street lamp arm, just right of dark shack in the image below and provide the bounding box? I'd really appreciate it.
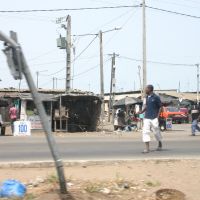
[99,31,105,120]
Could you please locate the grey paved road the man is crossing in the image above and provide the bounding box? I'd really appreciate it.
[0,125,200,162]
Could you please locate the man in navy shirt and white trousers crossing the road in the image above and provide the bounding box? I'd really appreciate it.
[140,85,162,153]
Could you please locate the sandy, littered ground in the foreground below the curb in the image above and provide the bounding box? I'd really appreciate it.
[0,160,200,200]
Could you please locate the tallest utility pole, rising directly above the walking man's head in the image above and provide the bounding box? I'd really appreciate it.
[142,0,147,92]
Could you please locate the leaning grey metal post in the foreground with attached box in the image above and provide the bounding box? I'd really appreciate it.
[0,32,67,194]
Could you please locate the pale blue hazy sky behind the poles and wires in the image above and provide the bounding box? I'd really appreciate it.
[0,0,200,93]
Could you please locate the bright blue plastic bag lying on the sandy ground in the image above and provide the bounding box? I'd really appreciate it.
[0,180,26,198]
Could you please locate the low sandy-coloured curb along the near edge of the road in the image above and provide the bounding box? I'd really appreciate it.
[0,158,200,169]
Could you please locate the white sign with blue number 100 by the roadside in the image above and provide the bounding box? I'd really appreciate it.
[13,121,31,136]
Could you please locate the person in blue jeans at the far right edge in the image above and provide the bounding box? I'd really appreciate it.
[191,105,200,136]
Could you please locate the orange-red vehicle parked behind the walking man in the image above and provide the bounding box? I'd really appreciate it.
[161,106,189,124]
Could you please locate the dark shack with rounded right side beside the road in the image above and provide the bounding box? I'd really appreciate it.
[53,93,102,132]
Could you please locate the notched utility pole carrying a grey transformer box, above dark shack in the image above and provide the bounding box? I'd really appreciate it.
[66,15,72,93]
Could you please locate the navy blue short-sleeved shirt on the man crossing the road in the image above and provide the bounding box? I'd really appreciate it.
[145,94,162,119]
